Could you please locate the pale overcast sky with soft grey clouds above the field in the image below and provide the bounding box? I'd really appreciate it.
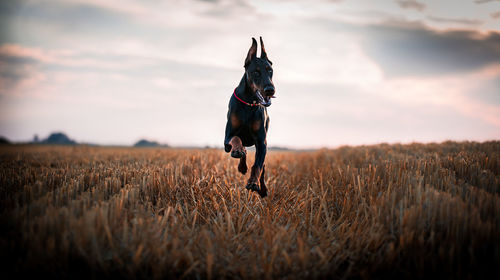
[0,0,500,148]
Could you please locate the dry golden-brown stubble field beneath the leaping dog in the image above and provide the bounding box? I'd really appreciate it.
[0,142,500,279]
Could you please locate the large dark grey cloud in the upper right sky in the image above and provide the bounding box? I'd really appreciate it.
[363,19,500,77]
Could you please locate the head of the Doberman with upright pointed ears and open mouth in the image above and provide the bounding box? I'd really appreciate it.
[245,37,275,107]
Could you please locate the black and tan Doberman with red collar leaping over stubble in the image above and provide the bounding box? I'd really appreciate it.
[224,37,274,197]
